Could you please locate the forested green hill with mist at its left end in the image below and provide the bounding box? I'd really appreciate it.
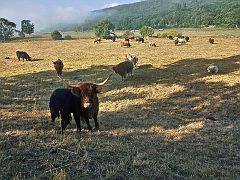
[70,0,240,30]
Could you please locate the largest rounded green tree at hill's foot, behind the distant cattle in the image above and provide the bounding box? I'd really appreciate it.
[94,19,115,38]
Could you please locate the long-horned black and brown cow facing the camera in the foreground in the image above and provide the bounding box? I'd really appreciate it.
[49,73,112,134]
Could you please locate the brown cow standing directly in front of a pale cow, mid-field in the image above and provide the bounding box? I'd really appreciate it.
[113,61,133,81]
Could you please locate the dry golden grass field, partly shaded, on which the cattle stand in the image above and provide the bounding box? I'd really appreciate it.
[0,30,240,180]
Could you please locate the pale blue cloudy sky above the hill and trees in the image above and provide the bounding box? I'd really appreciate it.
[0,0,141,30]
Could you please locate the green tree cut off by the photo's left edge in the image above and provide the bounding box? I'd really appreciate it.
[0,18,16,41]
